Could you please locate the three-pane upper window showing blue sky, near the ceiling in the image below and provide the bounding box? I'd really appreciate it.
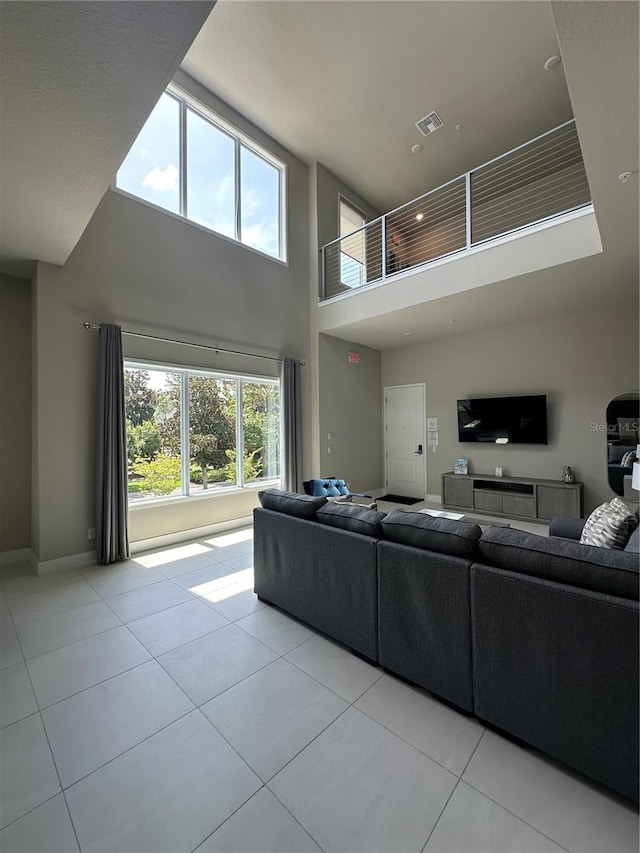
[116,89,285,260]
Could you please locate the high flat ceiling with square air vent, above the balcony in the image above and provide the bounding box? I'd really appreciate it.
[182,0,572,211]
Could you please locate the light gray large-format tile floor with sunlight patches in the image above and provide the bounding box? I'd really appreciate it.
[0,522,638,853]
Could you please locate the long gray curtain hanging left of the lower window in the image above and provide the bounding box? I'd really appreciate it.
[96,323,130,563]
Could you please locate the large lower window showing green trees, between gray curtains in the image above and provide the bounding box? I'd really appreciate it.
[124,363,280,502]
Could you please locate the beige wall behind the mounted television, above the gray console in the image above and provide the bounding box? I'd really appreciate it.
[382,304,639,512]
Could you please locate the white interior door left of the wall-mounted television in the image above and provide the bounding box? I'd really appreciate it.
[384,385,427,499]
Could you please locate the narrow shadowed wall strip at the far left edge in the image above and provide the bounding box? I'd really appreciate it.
[0,275,31,553]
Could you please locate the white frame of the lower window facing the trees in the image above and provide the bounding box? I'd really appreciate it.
[122,358,282,511]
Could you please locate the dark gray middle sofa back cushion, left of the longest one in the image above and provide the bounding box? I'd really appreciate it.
[382,509,482,560]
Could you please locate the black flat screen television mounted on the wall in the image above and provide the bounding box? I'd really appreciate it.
[458,394,547,444]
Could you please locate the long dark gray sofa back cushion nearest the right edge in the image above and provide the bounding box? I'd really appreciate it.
[478,527,638,599]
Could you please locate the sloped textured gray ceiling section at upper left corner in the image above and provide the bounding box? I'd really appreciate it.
[0,0,213,277]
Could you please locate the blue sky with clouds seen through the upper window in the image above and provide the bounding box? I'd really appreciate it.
[116,94,279,257]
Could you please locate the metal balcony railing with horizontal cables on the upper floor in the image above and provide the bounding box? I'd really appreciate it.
[320,119,591,300]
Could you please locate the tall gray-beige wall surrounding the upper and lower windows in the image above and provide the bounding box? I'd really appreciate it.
[33,76,309,560]
